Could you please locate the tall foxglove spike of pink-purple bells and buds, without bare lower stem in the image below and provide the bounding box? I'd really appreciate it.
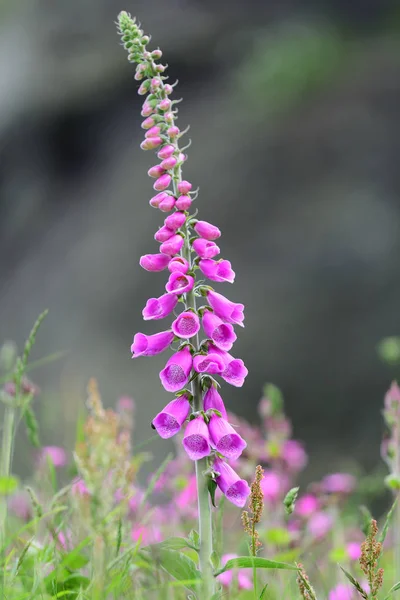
[118,12,250,507]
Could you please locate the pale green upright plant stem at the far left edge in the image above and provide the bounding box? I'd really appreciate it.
[0,406,15,597]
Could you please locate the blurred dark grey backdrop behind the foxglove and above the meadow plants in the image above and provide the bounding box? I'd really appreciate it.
[0,0,400,478]
